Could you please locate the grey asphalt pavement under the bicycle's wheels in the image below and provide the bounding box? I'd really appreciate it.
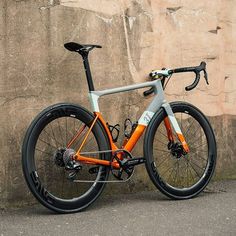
[0,180,236,236]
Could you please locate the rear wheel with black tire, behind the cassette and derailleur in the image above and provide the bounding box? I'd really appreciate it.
[22,104,110,213]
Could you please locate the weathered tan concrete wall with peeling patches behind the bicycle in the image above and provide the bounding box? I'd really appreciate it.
[0,0,236,206]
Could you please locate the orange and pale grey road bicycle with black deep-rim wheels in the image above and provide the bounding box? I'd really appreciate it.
[22,42,217,213]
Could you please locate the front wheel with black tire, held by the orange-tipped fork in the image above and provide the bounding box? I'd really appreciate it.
[144,102,217,199]
